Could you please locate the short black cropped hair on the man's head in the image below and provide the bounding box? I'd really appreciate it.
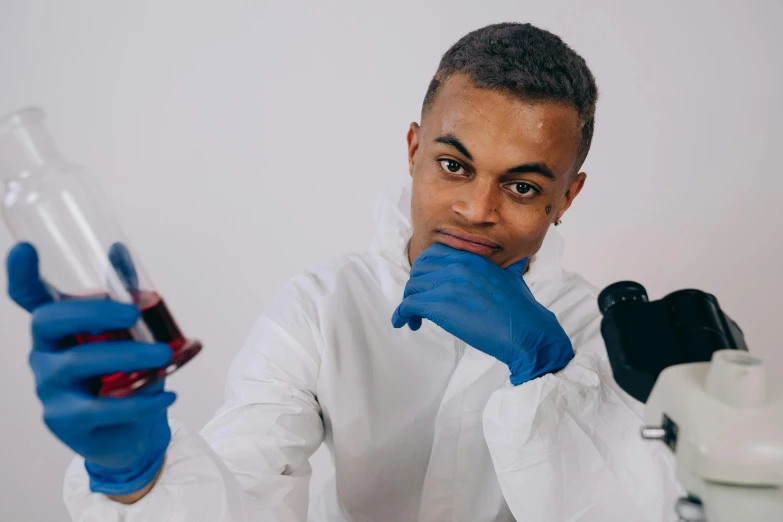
[421,23,598,169]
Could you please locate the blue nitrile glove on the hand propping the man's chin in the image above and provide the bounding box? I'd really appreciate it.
[392,243,574,385]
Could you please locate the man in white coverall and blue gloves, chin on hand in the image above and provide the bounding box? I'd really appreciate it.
[8,24,678,522]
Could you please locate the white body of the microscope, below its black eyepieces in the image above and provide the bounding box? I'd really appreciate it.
[642,350,783,522]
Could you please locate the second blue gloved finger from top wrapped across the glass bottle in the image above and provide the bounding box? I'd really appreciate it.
[45,341,172,382]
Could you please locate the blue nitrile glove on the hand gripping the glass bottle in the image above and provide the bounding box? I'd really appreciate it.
[8,243,175,495]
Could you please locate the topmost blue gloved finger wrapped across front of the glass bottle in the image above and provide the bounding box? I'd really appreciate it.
[32,299,140,350]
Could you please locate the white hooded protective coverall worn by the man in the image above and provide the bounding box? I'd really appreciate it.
[65,179,680,522]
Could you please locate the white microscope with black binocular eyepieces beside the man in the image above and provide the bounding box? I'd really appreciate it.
[598,281,783,522]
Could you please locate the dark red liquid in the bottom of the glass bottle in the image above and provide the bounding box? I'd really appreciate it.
[68,291,201,397]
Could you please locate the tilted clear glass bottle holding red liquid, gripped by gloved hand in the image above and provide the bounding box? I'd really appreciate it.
[0,108,201,397]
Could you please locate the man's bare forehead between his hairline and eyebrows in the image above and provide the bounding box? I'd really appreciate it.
[422,76,581,172]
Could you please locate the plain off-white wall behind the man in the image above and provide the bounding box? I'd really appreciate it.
[0,0,783,521]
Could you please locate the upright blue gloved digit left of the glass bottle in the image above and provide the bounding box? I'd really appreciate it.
[6,243,52,312]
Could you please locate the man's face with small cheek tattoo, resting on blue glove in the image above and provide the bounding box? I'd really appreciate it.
[408,76,586,268]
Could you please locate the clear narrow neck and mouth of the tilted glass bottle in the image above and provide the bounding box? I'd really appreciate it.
[0,108,62,181]
